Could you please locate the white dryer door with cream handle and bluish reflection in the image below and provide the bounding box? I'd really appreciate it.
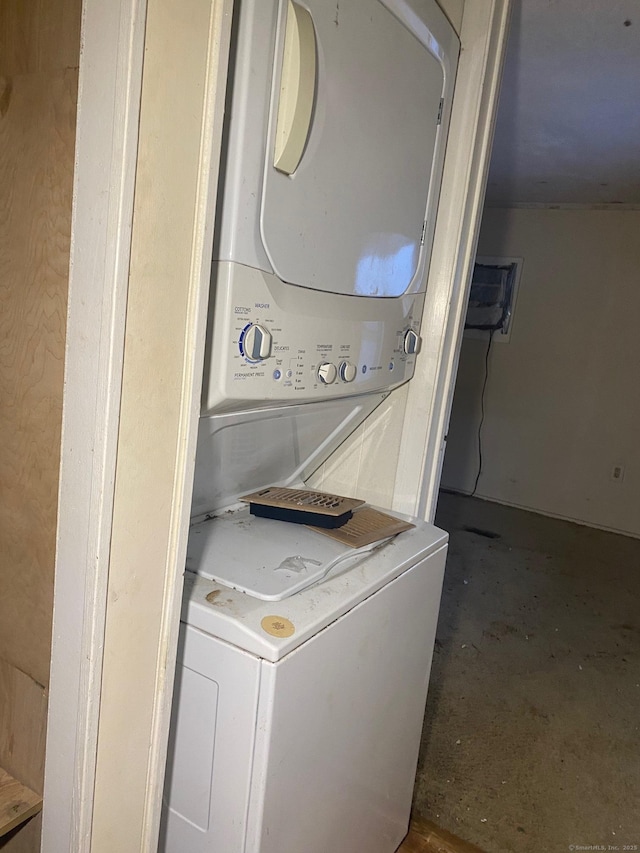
[260,0,455,296]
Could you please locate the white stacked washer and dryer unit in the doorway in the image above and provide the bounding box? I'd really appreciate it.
[160,0,459,853]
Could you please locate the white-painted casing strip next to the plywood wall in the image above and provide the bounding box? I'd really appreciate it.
[42,0,146,853]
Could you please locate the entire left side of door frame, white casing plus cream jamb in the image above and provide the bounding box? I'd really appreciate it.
[42,0,233,853]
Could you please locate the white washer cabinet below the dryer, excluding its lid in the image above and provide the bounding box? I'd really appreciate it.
[161,514,447,853]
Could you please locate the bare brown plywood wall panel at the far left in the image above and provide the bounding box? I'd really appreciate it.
[0,0,80,685]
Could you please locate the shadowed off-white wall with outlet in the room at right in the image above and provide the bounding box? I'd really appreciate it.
[442,209,640,536]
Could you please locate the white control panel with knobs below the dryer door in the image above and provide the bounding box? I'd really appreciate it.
[202,262,424,415]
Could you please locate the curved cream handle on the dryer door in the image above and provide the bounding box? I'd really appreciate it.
[273,0,316,175]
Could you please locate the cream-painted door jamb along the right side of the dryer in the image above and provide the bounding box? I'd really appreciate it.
[393,0,511,521]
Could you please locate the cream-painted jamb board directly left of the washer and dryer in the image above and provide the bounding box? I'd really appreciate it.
[92,0,232,853]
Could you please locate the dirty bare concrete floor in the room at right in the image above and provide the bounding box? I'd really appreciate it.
[414,493,640,853]
